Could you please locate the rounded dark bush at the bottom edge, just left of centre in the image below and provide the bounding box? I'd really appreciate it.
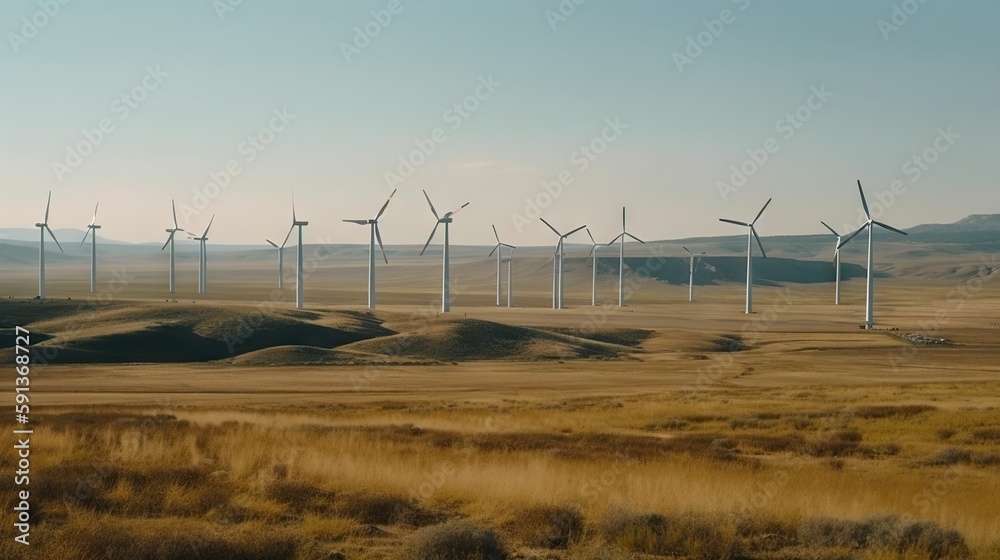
[397,519,510,560]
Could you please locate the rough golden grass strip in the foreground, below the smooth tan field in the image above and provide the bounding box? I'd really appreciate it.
[0,383,1000,559]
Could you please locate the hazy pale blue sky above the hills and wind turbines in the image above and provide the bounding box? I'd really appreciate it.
[0,0,1000,245]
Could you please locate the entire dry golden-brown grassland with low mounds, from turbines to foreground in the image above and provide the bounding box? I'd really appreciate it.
[0,250,1000,560]
